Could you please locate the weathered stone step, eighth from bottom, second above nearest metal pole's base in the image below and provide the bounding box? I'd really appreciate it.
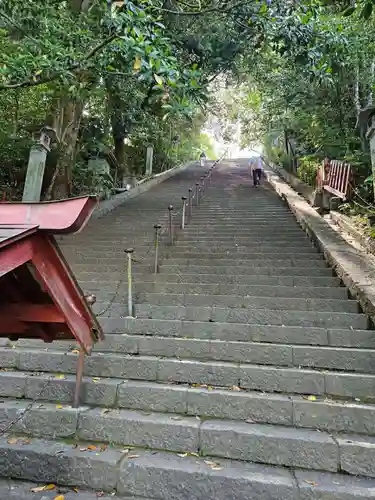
[134,291,359,313]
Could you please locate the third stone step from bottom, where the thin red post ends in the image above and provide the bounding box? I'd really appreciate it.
[0,378,375,436]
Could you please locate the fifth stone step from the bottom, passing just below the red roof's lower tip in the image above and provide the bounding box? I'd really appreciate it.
[7,334,375,373]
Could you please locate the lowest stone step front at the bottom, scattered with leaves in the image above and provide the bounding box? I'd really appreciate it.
[0,440,375,500]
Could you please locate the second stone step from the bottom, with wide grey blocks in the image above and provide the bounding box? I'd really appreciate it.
[0,400,375,474]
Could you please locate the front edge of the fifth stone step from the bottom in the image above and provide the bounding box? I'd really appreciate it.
[0,334,375,376]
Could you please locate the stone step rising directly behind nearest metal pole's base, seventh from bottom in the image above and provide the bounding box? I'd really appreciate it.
[134,304,368,330]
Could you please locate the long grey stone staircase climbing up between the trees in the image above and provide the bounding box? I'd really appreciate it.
[0,162,375,500]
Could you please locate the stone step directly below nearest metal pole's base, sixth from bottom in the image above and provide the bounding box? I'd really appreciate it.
[99,317,375,349]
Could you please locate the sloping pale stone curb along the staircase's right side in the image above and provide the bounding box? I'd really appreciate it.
[265,167,375,322]
